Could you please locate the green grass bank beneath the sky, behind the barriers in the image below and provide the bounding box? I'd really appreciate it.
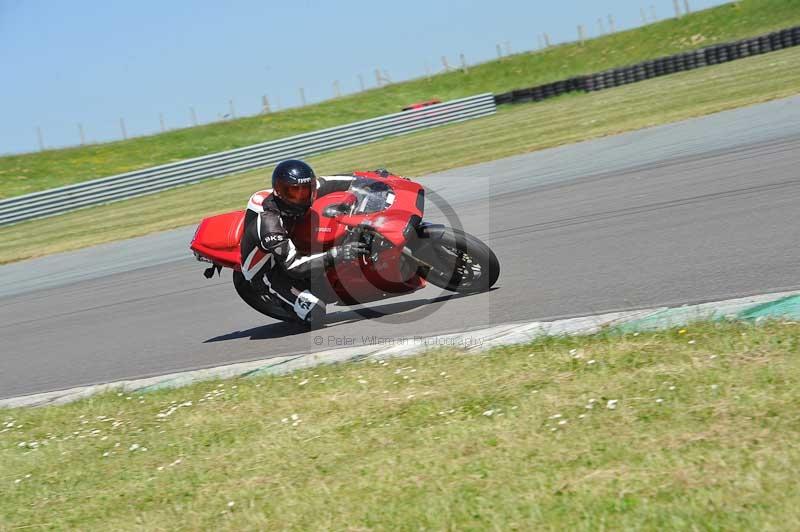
[0,0,800,198]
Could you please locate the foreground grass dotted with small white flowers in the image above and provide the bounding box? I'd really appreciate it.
[0,323,800,531]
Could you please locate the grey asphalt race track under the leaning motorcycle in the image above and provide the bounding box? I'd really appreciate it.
[0,98,800,398]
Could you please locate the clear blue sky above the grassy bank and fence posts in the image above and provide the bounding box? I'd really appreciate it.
[0,0,724,153]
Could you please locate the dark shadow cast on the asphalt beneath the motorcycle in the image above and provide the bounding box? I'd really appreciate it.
[203,294,482,344]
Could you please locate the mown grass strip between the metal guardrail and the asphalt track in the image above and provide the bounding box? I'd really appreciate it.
[0,44,800,263]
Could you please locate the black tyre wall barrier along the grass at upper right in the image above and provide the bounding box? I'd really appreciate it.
[494,26,800,105]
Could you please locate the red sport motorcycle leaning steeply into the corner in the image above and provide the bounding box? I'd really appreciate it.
[190,171,500,321]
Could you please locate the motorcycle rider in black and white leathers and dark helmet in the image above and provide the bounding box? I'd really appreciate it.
[241,159,368,328]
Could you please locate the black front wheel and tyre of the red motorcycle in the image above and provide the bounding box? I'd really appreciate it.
[415,228,500,293]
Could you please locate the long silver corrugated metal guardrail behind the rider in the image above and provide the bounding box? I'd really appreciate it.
[0,93,497,225]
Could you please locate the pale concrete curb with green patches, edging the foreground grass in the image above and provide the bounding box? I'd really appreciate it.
[0,290,800,408]
